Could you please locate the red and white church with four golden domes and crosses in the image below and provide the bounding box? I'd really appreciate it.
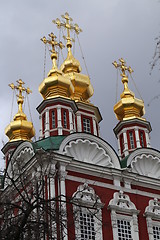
[2,13,160,240]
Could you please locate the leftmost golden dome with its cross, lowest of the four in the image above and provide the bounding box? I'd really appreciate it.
[5,79,35,142]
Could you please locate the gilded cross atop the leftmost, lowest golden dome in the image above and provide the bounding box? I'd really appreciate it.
[9,79,32,112]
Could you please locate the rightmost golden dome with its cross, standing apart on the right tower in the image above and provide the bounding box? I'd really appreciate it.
[113,58,145,121]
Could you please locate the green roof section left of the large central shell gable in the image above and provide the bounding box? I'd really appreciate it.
[32,136,66,151]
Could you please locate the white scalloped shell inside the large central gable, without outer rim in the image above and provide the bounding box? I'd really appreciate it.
[64,139,114,167]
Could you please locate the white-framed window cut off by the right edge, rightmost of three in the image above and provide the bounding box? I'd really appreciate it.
[144,198,160,240]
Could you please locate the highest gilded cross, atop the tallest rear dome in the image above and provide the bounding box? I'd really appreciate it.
[52,12,82,47]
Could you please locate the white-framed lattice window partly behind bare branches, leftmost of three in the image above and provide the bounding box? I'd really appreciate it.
[73,183,103,240]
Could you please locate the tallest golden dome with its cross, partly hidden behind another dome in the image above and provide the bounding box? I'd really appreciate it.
[53,12,94,102]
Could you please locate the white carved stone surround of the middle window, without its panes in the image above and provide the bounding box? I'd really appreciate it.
[108,191,139,240]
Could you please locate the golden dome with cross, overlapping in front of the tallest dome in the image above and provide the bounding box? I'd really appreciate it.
[39,33,74,99]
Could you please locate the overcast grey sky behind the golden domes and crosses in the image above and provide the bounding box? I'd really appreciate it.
[0,0,160,169]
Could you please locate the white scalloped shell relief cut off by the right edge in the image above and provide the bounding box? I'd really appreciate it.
[131,154,160,178]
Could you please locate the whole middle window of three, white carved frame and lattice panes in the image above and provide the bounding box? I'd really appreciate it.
[108,191,139,240]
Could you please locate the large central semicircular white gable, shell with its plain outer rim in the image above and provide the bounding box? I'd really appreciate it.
[59,133,120,169]
